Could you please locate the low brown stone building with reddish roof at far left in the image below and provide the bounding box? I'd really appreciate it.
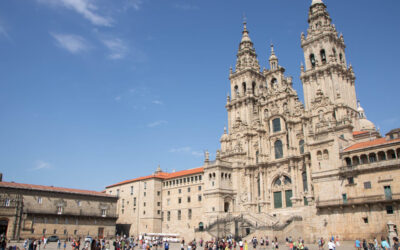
[0,182,118,239]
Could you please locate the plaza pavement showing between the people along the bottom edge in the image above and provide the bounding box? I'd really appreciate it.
[7,241,355,250]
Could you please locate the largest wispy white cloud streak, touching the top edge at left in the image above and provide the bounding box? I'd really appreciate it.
[37,0,113,26]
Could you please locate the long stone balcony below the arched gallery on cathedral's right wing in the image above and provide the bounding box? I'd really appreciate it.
[316,193,400,208]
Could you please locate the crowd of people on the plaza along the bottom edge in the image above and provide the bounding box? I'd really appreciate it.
[0,232,400,250]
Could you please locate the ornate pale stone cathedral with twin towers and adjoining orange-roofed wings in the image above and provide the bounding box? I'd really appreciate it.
[106,0,400,241]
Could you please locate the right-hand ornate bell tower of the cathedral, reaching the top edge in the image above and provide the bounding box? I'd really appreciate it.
[300,0,357,111]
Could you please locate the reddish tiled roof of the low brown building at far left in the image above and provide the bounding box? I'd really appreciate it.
[0,181,115,197]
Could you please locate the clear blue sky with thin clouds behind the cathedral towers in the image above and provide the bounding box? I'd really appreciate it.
[0,0,400,190]
